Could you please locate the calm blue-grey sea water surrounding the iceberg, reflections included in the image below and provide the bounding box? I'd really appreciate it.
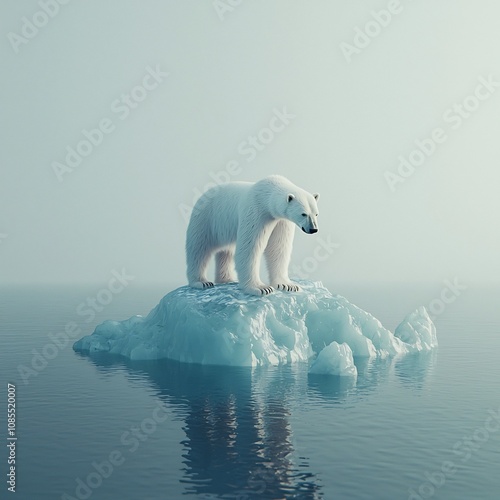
[0,287,500,500]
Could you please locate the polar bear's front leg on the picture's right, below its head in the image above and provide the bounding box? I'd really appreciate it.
[264,220,300,292]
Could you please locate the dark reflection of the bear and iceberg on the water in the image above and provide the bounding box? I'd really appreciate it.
[77,353,435,500]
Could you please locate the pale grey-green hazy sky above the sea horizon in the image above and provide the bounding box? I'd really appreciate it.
[0,0,500,285]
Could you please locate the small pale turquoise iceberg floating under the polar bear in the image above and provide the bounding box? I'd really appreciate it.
[73,280,438,376]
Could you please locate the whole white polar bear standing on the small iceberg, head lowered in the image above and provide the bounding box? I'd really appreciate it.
[186,175,319,295]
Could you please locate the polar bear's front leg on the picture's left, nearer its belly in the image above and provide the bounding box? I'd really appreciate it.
[235,217,274,295]
